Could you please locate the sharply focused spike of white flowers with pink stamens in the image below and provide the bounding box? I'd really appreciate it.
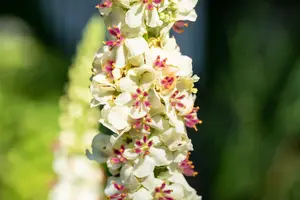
[86,0,201,200]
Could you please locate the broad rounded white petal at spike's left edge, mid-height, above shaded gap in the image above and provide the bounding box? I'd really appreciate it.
[107,106,129,130]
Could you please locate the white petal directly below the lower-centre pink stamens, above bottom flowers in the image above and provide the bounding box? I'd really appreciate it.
[133,156,155,178]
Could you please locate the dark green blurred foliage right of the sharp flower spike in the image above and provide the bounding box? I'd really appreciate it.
[203,3,300,200]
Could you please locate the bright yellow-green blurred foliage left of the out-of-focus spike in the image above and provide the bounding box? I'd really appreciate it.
[0,18,68,200]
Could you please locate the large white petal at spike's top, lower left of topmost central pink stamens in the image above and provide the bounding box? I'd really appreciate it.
[125,1,145,28]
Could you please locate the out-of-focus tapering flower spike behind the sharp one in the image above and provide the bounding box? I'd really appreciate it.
[49,17,105,200]
